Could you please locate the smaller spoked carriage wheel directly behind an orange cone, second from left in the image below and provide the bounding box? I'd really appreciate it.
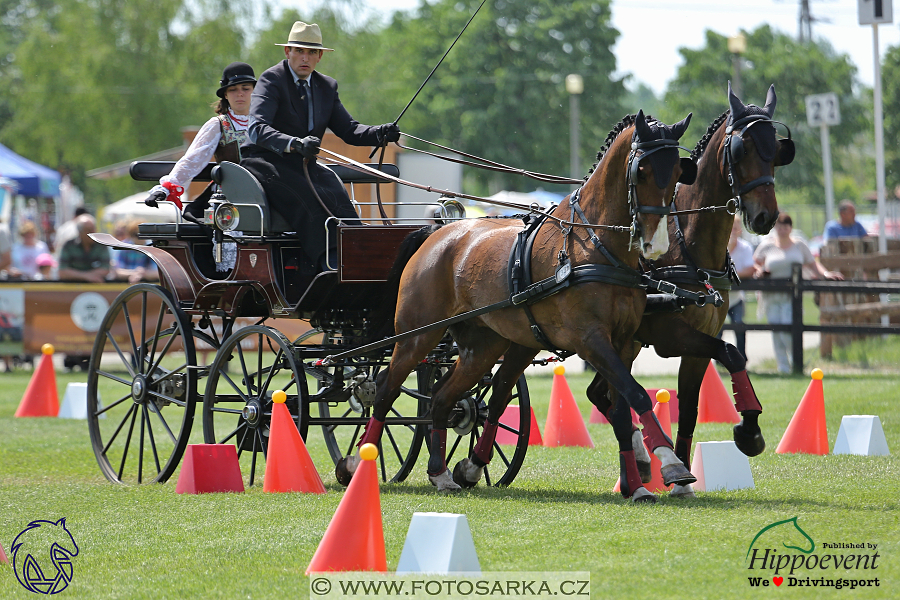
[203,325,308,486]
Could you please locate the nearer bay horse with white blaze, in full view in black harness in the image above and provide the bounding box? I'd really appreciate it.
[336,111,696,501]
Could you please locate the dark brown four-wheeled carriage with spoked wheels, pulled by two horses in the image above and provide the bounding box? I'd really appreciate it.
[88,162,531,485]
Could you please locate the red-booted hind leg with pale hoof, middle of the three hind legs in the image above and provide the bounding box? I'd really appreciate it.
[428,326,510,491]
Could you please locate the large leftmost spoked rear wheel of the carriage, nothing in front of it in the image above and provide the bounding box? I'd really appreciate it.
[87,283,197,483]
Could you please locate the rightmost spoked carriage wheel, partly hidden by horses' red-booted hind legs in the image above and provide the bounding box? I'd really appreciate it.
[425,369,531,487]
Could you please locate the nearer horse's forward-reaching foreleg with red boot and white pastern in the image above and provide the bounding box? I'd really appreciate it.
[579,332,697,485]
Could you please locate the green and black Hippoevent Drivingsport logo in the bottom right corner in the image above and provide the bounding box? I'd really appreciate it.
[746,517,881,590]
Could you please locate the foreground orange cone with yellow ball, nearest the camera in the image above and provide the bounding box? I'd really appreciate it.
[306,444,387,575]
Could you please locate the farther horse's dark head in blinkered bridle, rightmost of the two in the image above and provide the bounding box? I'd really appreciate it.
[718,82,794,234]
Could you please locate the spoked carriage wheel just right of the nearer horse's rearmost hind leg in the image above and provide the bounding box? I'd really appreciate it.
[307,365,428,483]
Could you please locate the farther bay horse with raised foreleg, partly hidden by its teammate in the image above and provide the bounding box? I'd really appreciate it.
[588,83,795,497]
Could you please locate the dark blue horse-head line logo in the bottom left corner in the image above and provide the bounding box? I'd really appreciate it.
[11,517,78,594]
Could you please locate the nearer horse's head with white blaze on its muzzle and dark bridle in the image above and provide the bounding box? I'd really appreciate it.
[626,111,697,260]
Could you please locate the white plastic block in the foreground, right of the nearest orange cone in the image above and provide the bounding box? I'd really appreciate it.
[397,513,481,575]
